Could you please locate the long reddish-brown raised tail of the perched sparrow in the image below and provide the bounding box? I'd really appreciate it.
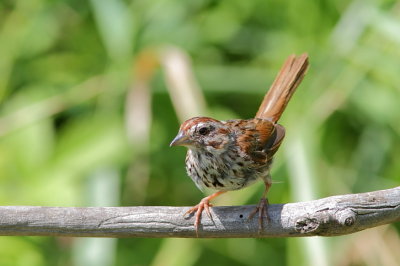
[256,53,308,122]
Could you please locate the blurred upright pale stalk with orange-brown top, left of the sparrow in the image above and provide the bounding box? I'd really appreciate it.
[124,50,158,204]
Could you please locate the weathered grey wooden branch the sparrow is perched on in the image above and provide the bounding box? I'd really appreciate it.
[0,187,400,238]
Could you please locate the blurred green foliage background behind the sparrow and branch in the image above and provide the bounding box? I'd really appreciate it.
[0,0,400,266]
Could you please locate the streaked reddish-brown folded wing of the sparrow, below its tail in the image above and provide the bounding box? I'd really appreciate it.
[237,118,285,163]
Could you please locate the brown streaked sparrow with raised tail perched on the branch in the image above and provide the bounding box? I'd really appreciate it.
[170,54,308,234]
